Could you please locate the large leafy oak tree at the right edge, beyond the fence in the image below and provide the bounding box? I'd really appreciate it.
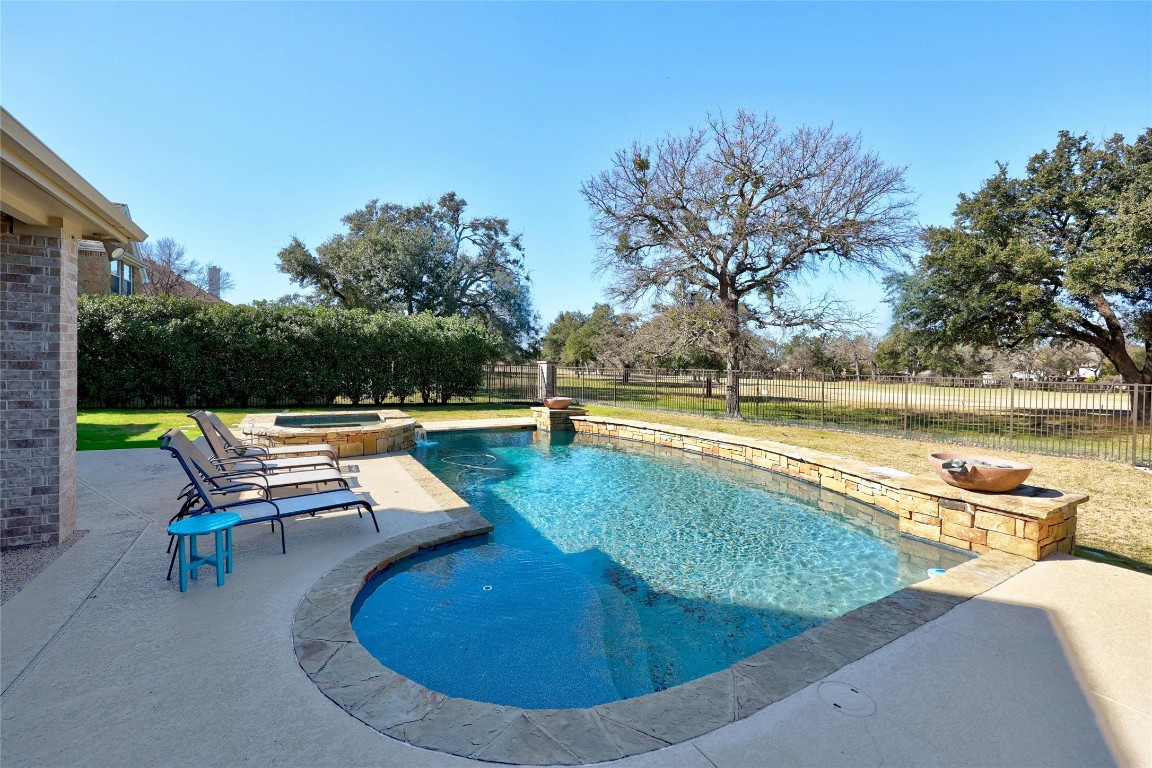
[889,129,1152,419]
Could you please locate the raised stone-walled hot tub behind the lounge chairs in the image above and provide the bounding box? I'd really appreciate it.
[240,410,416,458]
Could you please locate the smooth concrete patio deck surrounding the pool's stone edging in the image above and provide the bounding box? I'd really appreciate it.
[0,423,1152,768]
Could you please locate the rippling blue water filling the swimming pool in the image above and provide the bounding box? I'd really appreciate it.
[353,432,967,708]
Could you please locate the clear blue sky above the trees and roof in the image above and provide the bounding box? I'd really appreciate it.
[0,1,1152,333]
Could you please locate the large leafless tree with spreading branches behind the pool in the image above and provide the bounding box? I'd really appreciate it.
[581,111,915,418]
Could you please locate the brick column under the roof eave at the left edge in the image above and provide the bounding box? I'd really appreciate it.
[0,230,78,549]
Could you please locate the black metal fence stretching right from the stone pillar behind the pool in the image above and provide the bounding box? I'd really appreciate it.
[543,366,1152,465]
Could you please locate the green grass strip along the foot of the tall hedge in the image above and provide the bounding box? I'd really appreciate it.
[76,403,531,450]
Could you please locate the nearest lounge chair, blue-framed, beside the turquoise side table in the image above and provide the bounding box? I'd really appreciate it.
[160,429,380,552]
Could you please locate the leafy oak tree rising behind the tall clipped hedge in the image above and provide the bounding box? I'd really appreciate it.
[278,192,538,350]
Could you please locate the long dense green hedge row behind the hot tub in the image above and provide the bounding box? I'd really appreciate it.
[77,296,499,408]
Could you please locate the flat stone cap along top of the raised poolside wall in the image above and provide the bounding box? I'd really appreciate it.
[573,416,1089,519]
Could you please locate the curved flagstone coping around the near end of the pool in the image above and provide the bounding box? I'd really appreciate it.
[293,455,1032,765]
